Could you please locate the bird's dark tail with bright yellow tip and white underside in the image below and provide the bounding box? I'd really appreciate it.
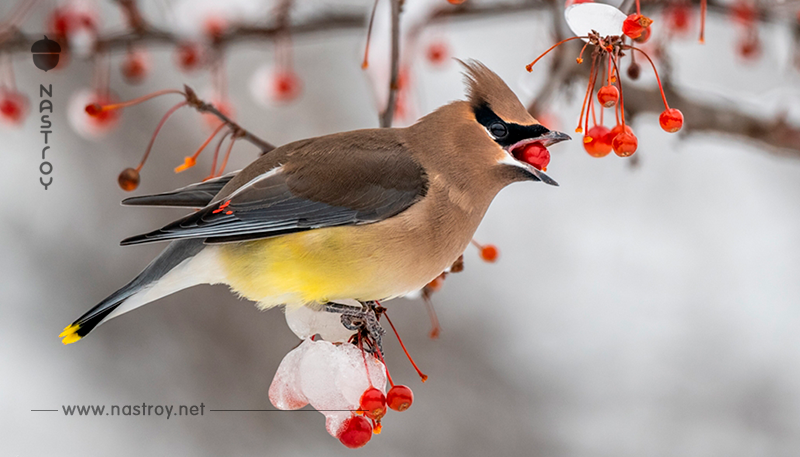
[59,239,215,344]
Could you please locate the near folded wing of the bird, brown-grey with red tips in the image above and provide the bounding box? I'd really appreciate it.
[122,138,428,245]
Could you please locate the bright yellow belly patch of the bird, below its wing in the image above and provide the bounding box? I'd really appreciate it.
[219,227,384,308]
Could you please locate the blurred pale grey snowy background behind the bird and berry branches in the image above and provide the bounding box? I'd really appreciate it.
[0,0,800,457]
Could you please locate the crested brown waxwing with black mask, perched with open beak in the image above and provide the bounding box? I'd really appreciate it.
[59,60,570,344]
